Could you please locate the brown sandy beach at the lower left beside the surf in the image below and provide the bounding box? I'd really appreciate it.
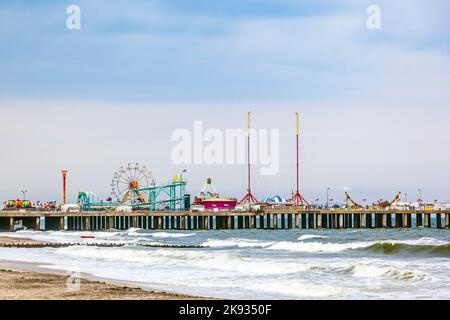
[0,237,202,300]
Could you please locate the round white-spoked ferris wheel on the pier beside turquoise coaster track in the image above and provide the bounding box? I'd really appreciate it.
[111,163,155,204]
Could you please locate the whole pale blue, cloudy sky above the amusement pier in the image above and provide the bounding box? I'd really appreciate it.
[0,0,450,202]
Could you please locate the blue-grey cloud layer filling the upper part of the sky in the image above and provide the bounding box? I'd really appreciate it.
[0,1,449,102]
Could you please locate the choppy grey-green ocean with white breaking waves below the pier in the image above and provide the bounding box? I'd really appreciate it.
[0,228,450,299]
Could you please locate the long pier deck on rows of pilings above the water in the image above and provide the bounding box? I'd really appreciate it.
[0,207,450,231]
